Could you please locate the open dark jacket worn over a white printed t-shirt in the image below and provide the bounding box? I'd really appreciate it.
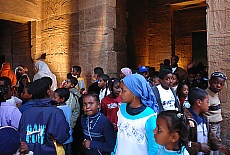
[152,86,181,113]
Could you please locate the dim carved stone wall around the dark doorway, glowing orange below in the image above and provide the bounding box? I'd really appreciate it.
[173,7,207,69]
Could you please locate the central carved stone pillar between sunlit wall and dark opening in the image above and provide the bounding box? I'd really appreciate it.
[79,0,117,84]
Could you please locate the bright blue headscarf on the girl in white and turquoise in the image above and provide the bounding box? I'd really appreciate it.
[122,74,158,112]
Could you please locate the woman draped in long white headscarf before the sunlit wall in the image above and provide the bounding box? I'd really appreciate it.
[33,60,57,91]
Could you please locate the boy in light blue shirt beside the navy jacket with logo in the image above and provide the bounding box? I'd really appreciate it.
[54,88,73,155]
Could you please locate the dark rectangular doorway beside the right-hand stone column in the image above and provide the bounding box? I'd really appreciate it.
[192,31,208,66]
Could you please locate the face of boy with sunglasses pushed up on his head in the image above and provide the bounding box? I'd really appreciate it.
[209,77,225,93]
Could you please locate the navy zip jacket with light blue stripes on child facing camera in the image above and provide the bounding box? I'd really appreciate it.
[81,112,116,155]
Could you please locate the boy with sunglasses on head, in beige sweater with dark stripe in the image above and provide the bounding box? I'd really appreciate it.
[205,72,227,155]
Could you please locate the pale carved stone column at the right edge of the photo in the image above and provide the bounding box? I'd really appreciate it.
[207,0,230,148]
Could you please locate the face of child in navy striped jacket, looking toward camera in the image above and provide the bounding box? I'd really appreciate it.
[83,96,100,116]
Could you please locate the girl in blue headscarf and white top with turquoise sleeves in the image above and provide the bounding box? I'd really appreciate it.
[115,74,158,155]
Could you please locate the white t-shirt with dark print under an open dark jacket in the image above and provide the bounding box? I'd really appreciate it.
[157,85,176,111]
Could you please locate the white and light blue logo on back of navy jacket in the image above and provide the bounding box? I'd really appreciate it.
[26,124,46,145]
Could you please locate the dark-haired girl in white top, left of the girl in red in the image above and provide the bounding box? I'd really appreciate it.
[98,74,110,102]
